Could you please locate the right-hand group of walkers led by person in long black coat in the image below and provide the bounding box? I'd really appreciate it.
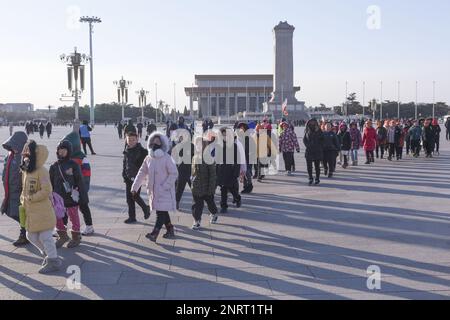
[303,118,442,185]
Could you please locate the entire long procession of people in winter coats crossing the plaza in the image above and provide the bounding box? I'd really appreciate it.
[1,117,449,273]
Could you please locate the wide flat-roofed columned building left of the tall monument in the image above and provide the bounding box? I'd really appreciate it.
[185,74,290,117]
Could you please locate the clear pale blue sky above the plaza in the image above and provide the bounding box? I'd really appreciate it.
[0,0,450,110]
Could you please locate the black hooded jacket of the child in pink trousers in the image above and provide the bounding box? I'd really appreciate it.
[50,140,89,208]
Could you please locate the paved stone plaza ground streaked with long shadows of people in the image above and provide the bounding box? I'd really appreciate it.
[0,126,450,300]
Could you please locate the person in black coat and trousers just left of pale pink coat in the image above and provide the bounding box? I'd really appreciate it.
[122,132,150,224]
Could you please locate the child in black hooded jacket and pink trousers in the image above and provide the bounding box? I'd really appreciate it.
[50,140,88,248]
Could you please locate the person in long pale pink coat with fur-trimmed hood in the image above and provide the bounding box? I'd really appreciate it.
[131,132,178,242]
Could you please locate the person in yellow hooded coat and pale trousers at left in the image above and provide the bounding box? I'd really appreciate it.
[20,140,62,274]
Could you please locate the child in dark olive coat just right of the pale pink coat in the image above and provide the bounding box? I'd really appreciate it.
[192,137,218,230]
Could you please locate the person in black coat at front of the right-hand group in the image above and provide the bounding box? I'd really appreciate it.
[303,119,324,186]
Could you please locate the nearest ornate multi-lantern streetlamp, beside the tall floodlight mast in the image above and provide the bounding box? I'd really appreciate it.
[60,47,90,132]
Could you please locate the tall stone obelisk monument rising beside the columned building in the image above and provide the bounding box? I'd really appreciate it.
[265,21,308,120]
